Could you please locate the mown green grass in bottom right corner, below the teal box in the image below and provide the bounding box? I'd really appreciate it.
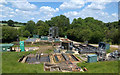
[77,61,118,73]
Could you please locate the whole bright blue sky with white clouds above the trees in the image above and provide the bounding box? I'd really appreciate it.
[0,0,118,22]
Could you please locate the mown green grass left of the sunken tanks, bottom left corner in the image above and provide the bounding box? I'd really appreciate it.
[2,51,44,73]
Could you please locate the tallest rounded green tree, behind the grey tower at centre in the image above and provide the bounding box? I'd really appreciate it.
[46,15,70,36]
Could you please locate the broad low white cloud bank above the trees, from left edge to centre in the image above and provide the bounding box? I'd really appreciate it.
[0,2,59,22]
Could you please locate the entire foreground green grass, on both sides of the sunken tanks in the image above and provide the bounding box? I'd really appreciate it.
[2,51,118,73]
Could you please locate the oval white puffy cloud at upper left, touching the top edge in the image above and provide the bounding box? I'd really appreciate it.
[11,0,37,11]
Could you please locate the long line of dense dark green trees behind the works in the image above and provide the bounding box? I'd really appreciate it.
[3,15,120,44]
